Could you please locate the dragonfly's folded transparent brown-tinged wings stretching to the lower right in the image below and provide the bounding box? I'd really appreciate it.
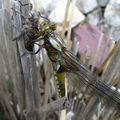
[62,49,120,110]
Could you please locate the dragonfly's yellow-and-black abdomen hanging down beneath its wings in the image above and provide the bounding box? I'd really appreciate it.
[45,44,65,97]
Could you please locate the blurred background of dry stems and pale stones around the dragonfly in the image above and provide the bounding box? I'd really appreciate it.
[0,0,120,120]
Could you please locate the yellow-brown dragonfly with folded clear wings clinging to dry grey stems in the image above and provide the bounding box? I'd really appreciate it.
[14,7,120,116]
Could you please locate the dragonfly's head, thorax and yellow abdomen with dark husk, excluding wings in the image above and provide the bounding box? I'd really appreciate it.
[13,2,65,96]
